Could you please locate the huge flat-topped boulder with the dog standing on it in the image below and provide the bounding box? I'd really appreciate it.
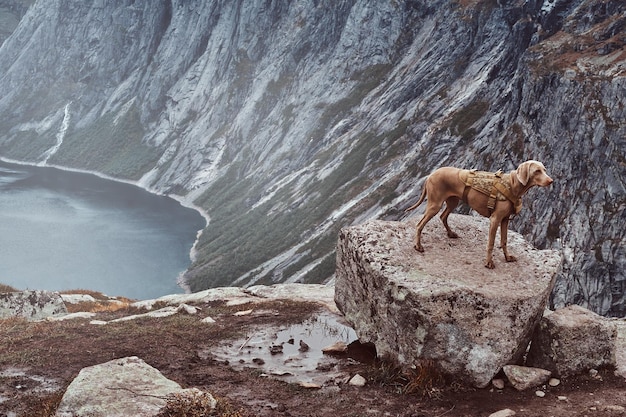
[335,215,561,387]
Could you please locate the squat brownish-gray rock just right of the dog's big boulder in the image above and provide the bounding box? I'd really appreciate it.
[526,305,617,377]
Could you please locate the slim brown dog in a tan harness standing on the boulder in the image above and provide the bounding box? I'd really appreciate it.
[405,160,553,269]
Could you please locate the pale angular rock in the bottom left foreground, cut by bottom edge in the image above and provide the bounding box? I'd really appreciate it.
[55,356,214,417]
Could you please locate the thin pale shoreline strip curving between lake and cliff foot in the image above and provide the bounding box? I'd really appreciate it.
[0,155,211,294]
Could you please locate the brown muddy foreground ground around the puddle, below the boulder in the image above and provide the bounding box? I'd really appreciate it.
[0,301,626,417]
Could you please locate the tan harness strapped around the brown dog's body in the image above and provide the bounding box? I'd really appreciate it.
[459,169,522,214]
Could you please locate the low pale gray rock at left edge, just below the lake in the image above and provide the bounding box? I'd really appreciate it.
[0,291,67,320]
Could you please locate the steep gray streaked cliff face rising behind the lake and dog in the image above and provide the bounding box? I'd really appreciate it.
[0,0,626,315]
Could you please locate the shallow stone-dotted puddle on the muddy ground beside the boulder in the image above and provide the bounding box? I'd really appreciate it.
[207,313,357,385]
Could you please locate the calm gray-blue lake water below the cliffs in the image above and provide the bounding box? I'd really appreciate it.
[0,161,205,299]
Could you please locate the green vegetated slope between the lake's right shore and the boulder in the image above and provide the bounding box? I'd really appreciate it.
[187,114,408,291]
